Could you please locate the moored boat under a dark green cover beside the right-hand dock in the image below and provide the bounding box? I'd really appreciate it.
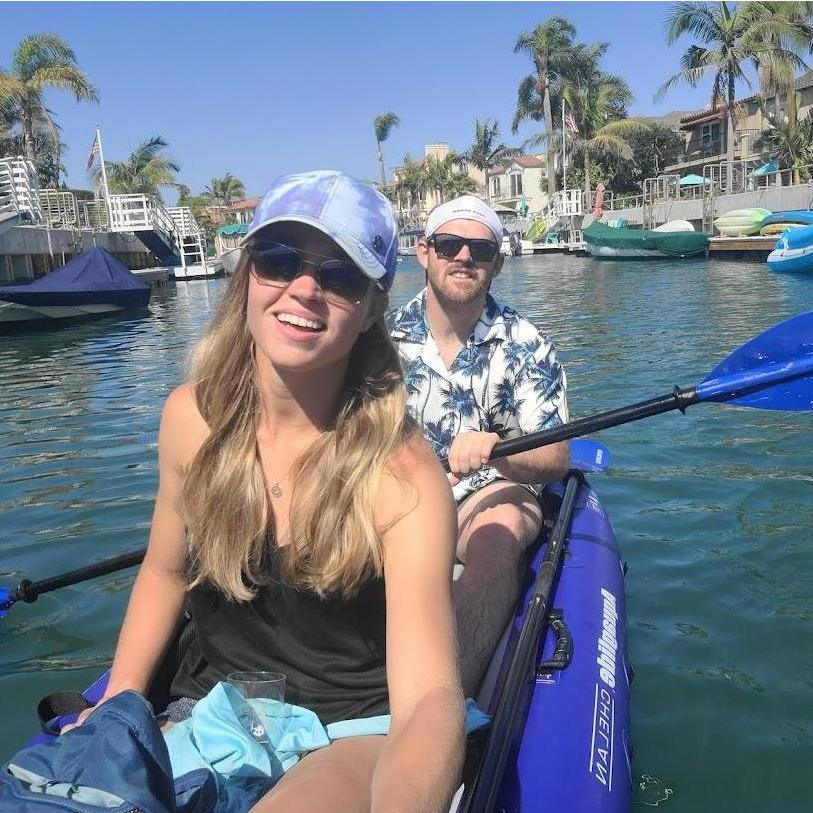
[582,222,709,260]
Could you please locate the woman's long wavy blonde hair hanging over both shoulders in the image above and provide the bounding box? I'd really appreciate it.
[179,252,406,601]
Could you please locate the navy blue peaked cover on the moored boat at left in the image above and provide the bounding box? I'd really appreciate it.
[0,248,150,308]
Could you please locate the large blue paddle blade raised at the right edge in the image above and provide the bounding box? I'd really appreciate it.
[697,313,813,411]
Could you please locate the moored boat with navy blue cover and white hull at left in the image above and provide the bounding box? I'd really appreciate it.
[0,247,150,325]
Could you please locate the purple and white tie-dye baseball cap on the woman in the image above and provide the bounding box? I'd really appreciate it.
[243,171,398,291]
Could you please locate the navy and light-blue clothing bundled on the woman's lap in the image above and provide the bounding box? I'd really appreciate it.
[0,683,489,813]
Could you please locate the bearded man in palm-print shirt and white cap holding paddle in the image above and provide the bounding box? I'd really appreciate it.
[388,195,569,695]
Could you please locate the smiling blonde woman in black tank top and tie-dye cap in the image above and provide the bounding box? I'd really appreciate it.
[70,172,463,813]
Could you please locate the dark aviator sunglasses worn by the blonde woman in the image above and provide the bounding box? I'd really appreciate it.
[248,242,380,305]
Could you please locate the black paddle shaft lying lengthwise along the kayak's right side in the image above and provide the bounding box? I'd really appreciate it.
[461,471,584,813]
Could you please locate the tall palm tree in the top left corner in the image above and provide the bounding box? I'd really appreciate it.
[0,34,99,186]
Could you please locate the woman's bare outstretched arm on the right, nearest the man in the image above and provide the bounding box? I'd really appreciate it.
[372,437,464,813]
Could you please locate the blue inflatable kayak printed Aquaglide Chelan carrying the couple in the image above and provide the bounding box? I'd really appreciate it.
[27,472,632,813]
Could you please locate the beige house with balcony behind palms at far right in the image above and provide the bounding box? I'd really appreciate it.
[664,71,813,175]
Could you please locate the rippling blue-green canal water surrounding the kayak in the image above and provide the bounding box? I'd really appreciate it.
[0,257,813,813]
